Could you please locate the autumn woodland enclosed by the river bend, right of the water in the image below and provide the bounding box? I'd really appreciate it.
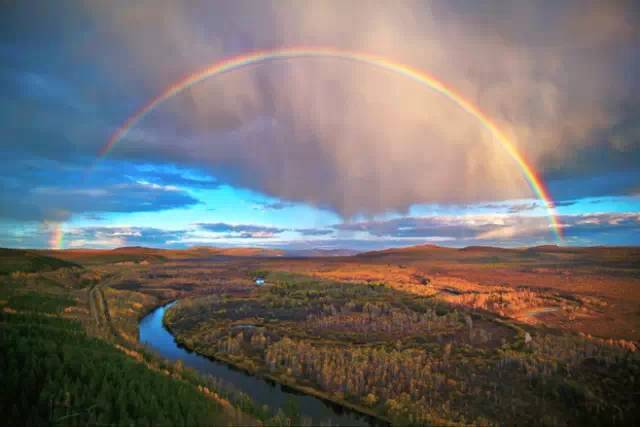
[165,272,640,425]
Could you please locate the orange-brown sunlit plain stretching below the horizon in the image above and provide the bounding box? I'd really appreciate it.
[45,245,640,341]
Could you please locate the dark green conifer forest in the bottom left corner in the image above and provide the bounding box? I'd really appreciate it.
[0,272,229,426]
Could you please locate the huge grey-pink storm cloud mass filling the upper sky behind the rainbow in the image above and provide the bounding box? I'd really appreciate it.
[0,0,640,229]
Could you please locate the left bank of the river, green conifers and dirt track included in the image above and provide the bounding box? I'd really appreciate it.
[0,250,320,426]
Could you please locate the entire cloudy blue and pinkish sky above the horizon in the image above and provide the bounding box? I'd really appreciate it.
[0,0,640,250]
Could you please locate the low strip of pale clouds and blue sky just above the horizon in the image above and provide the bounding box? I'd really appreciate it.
[0,213,640,250]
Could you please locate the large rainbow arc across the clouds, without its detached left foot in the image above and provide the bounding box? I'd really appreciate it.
[100,47,562,241]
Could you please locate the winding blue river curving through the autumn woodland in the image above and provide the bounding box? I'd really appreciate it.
[139,302,386,427]
